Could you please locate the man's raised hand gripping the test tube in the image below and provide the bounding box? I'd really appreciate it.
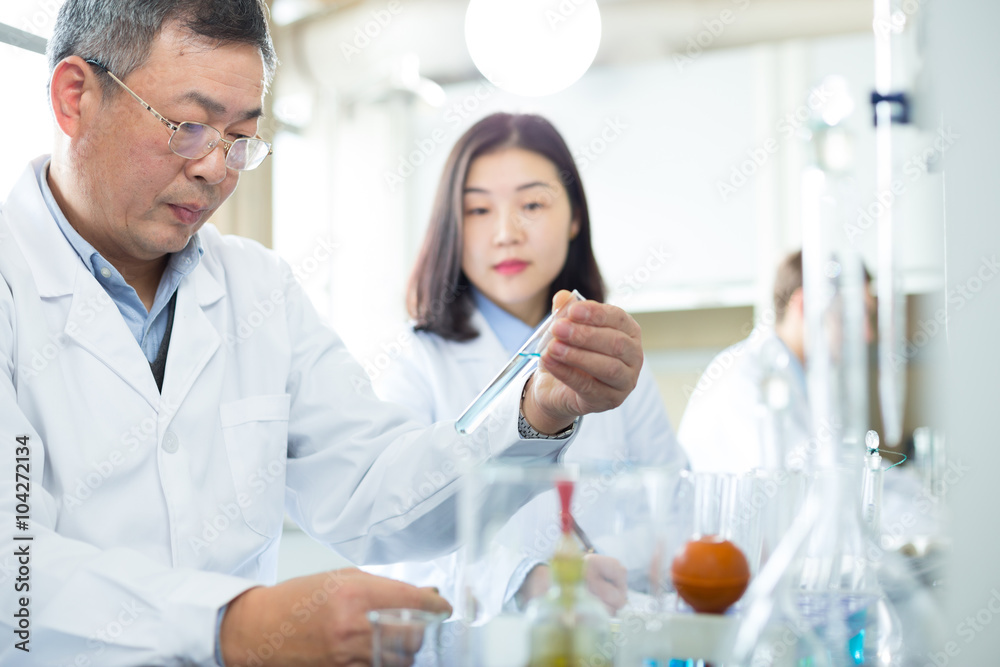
[522,291,642,433]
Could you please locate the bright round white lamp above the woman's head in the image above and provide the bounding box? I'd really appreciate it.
[465,0,601,97]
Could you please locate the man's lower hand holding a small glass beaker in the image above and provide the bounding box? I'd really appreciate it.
[219,569,451,667]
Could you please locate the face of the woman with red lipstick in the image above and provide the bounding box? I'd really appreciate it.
[462,148,580,326]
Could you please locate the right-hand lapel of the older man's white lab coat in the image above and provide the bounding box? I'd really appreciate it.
[161,265,225,421]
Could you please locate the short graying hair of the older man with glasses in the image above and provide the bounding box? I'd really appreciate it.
[47,0,277,94]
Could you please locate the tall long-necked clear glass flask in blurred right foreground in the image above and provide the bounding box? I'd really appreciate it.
[733,80,900,667]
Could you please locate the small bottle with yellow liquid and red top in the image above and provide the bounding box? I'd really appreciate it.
[527,481,614,667]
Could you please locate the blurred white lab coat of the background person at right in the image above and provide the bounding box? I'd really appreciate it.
[677,328,812,473]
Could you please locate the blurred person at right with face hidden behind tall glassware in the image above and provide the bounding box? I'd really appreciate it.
[678,251,940,539]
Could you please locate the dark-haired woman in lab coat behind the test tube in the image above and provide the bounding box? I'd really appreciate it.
[368,113,687,616]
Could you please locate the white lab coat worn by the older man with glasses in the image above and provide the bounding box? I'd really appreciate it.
[0,158,566,667]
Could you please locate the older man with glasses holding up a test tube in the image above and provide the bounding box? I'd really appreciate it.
[0,0,642,667]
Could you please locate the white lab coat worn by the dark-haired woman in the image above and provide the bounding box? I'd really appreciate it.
[365,310,687,620]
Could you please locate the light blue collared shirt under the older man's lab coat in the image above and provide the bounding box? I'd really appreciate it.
[36,162,205,362]
